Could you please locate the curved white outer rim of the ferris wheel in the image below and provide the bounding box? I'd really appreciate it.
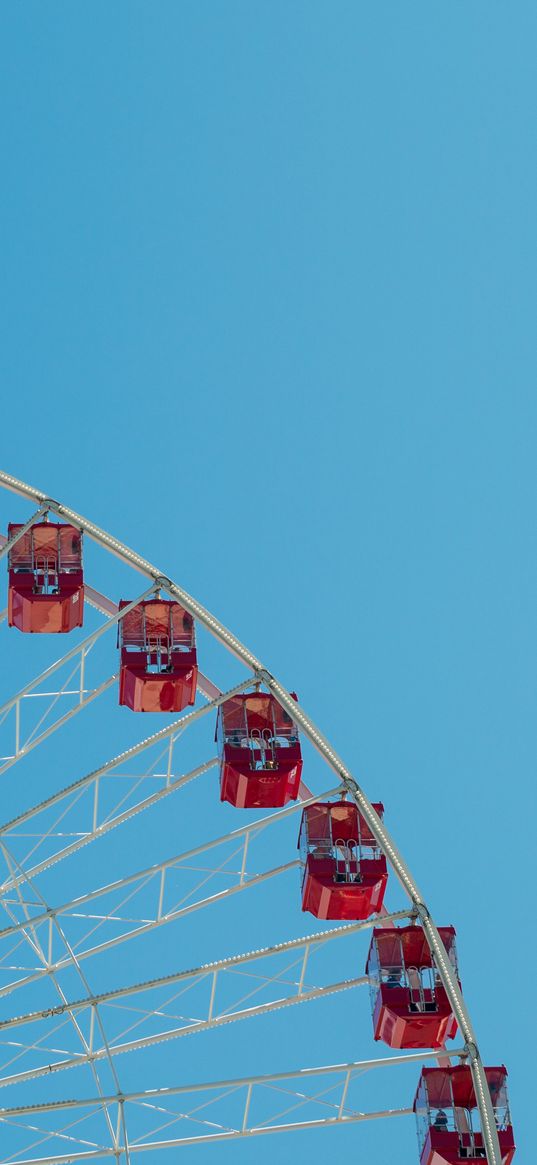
[0,469,502,1165]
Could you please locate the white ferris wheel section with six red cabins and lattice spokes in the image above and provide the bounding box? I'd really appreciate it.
[0,473,515,1165]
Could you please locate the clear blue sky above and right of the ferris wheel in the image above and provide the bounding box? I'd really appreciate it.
[0,0,537,1165]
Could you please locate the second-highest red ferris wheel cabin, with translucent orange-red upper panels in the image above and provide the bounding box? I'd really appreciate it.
[118,599,198,712]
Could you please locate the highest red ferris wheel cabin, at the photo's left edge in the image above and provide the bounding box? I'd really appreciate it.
[7,522,84,634]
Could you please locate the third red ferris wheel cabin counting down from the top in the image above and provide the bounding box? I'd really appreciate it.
[217,692,302,809]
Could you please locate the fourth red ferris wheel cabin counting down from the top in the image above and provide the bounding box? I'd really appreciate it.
[298,800,388,919]
